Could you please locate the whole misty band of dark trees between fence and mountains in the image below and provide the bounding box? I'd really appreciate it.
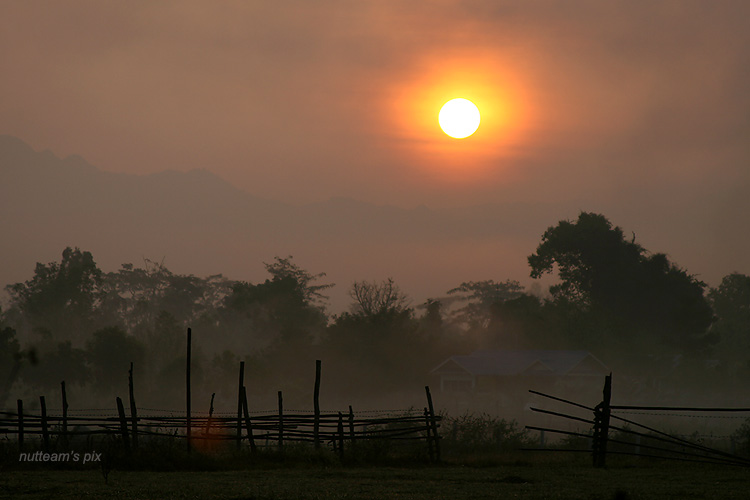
[0,212,750,407]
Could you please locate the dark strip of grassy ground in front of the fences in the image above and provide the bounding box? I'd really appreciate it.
[0,457,750,500]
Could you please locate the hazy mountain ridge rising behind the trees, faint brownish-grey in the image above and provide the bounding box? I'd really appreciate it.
[0,136,748,310]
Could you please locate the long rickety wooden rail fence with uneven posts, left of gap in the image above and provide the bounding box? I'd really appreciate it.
[0,328,442,461]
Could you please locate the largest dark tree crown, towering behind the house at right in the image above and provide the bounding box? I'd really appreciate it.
[528,212,713,352]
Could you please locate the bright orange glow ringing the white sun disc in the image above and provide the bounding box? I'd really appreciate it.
[384,51,533,184]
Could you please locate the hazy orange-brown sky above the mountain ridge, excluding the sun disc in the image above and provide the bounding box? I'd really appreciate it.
[0,0,750,207]
